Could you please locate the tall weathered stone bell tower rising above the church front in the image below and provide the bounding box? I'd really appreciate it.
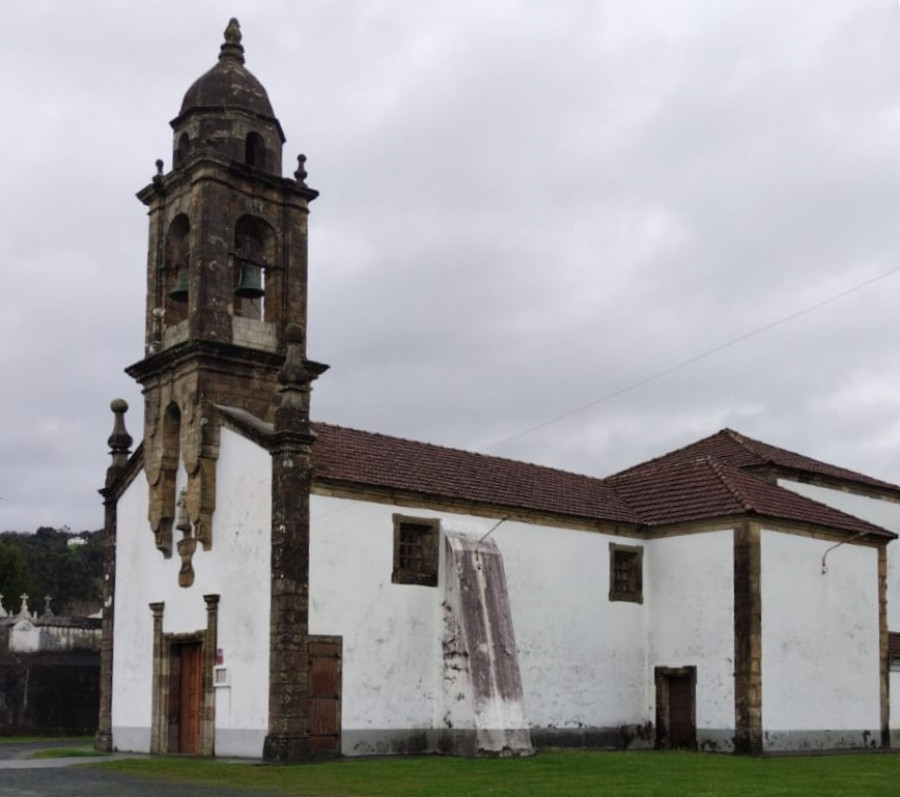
[127,19,325,557]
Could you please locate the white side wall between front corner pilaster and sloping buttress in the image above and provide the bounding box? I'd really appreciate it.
[309,495,443,754]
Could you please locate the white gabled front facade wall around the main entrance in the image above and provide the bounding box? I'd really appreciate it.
[112,422,271,756]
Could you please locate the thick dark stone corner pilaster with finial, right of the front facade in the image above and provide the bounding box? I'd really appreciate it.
[263,324,315,762]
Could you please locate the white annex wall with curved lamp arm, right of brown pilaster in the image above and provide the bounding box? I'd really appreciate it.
[760,530,881,750]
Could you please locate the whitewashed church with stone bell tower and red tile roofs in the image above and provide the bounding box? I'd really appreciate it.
[96,20,900,761]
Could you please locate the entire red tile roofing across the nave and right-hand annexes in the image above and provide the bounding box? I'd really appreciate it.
[219,407,900,538]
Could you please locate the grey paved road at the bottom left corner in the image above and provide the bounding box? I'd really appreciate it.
[0,741,288,797]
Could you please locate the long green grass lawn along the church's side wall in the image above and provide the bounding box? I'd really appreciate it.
[98,751,900,797]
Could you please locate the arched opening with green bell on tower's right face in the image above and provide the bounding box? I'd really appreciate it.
[232,216,276,321]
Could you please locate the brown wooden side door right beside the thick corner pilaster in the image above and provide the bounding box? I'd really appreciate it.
[309,636,342,756]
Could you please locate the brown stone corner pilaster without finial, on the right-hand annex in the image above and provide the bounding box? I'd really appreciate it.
[734,521,762,755]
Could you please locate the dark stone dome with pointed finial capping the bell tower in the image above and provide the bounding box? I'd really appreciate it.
[176,19,277,137]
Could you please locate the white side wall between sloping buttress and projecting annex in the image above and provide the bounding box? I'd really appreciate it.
[500,522,650,744]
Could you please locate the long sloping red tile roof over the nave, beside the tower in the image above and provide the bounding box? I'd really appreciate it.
[313,423,641,525]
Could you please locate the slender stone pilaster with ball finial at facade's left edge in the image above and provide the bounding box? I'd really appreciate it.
[94,399,132,753]
